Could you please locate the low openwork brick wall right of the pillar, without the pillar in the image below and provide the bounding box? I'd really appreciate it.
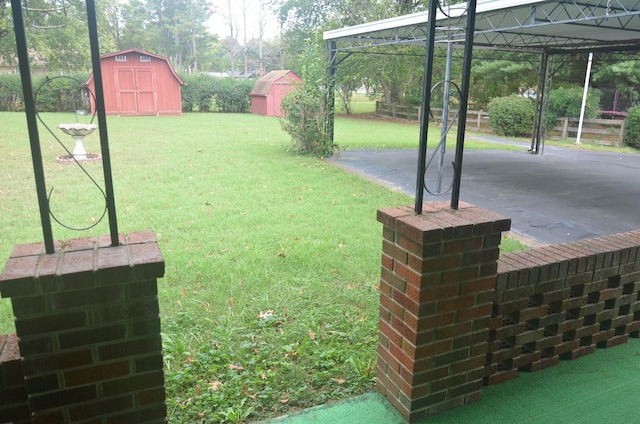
[485,231,640,384]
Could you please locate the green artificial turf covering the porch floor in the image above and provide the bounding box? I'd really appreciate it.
[263,339,640,424]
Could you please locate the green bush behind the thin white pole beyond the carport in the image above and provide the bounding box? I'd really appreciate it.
[546,87,602,129]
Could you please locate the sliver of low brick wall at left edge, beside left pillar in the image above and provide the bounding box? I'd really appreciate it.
[0,334,31,424]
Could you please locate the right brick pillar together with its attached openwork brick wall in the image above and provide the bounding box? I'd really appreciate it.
[377,203,640,422]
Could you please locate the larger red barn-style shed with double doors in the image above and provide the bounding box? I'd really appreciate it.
[87,49,185,116]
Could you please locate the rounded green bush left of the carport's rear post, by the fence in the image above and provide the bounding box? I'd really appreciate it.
[487,96,534,136]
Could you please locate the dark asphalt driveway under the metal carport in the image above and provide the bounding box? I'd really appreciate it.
[330,137,640,244]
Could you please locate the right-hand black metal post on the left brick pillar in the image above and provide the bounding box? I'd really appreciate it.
[86,0,120,246]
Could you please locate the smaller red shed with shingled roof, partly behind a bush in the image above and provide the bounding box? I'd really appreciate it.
[250,70,302,116]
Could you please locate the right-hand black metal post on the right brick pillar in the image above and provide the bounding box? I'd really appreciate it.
[451,0,477,209]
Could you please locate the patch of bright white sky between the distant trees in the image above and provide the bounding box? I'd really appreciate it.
[209,0,280,42]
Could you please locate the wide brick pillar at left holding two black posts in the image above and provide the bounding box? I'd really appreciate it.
[0,232,166,423]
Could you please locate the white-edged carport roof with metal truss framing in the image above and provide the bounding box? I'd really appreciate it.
[324,0,640,53]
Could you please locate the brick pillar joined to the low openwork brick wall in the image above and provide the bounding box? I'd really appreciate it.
[377,202,511,422]
